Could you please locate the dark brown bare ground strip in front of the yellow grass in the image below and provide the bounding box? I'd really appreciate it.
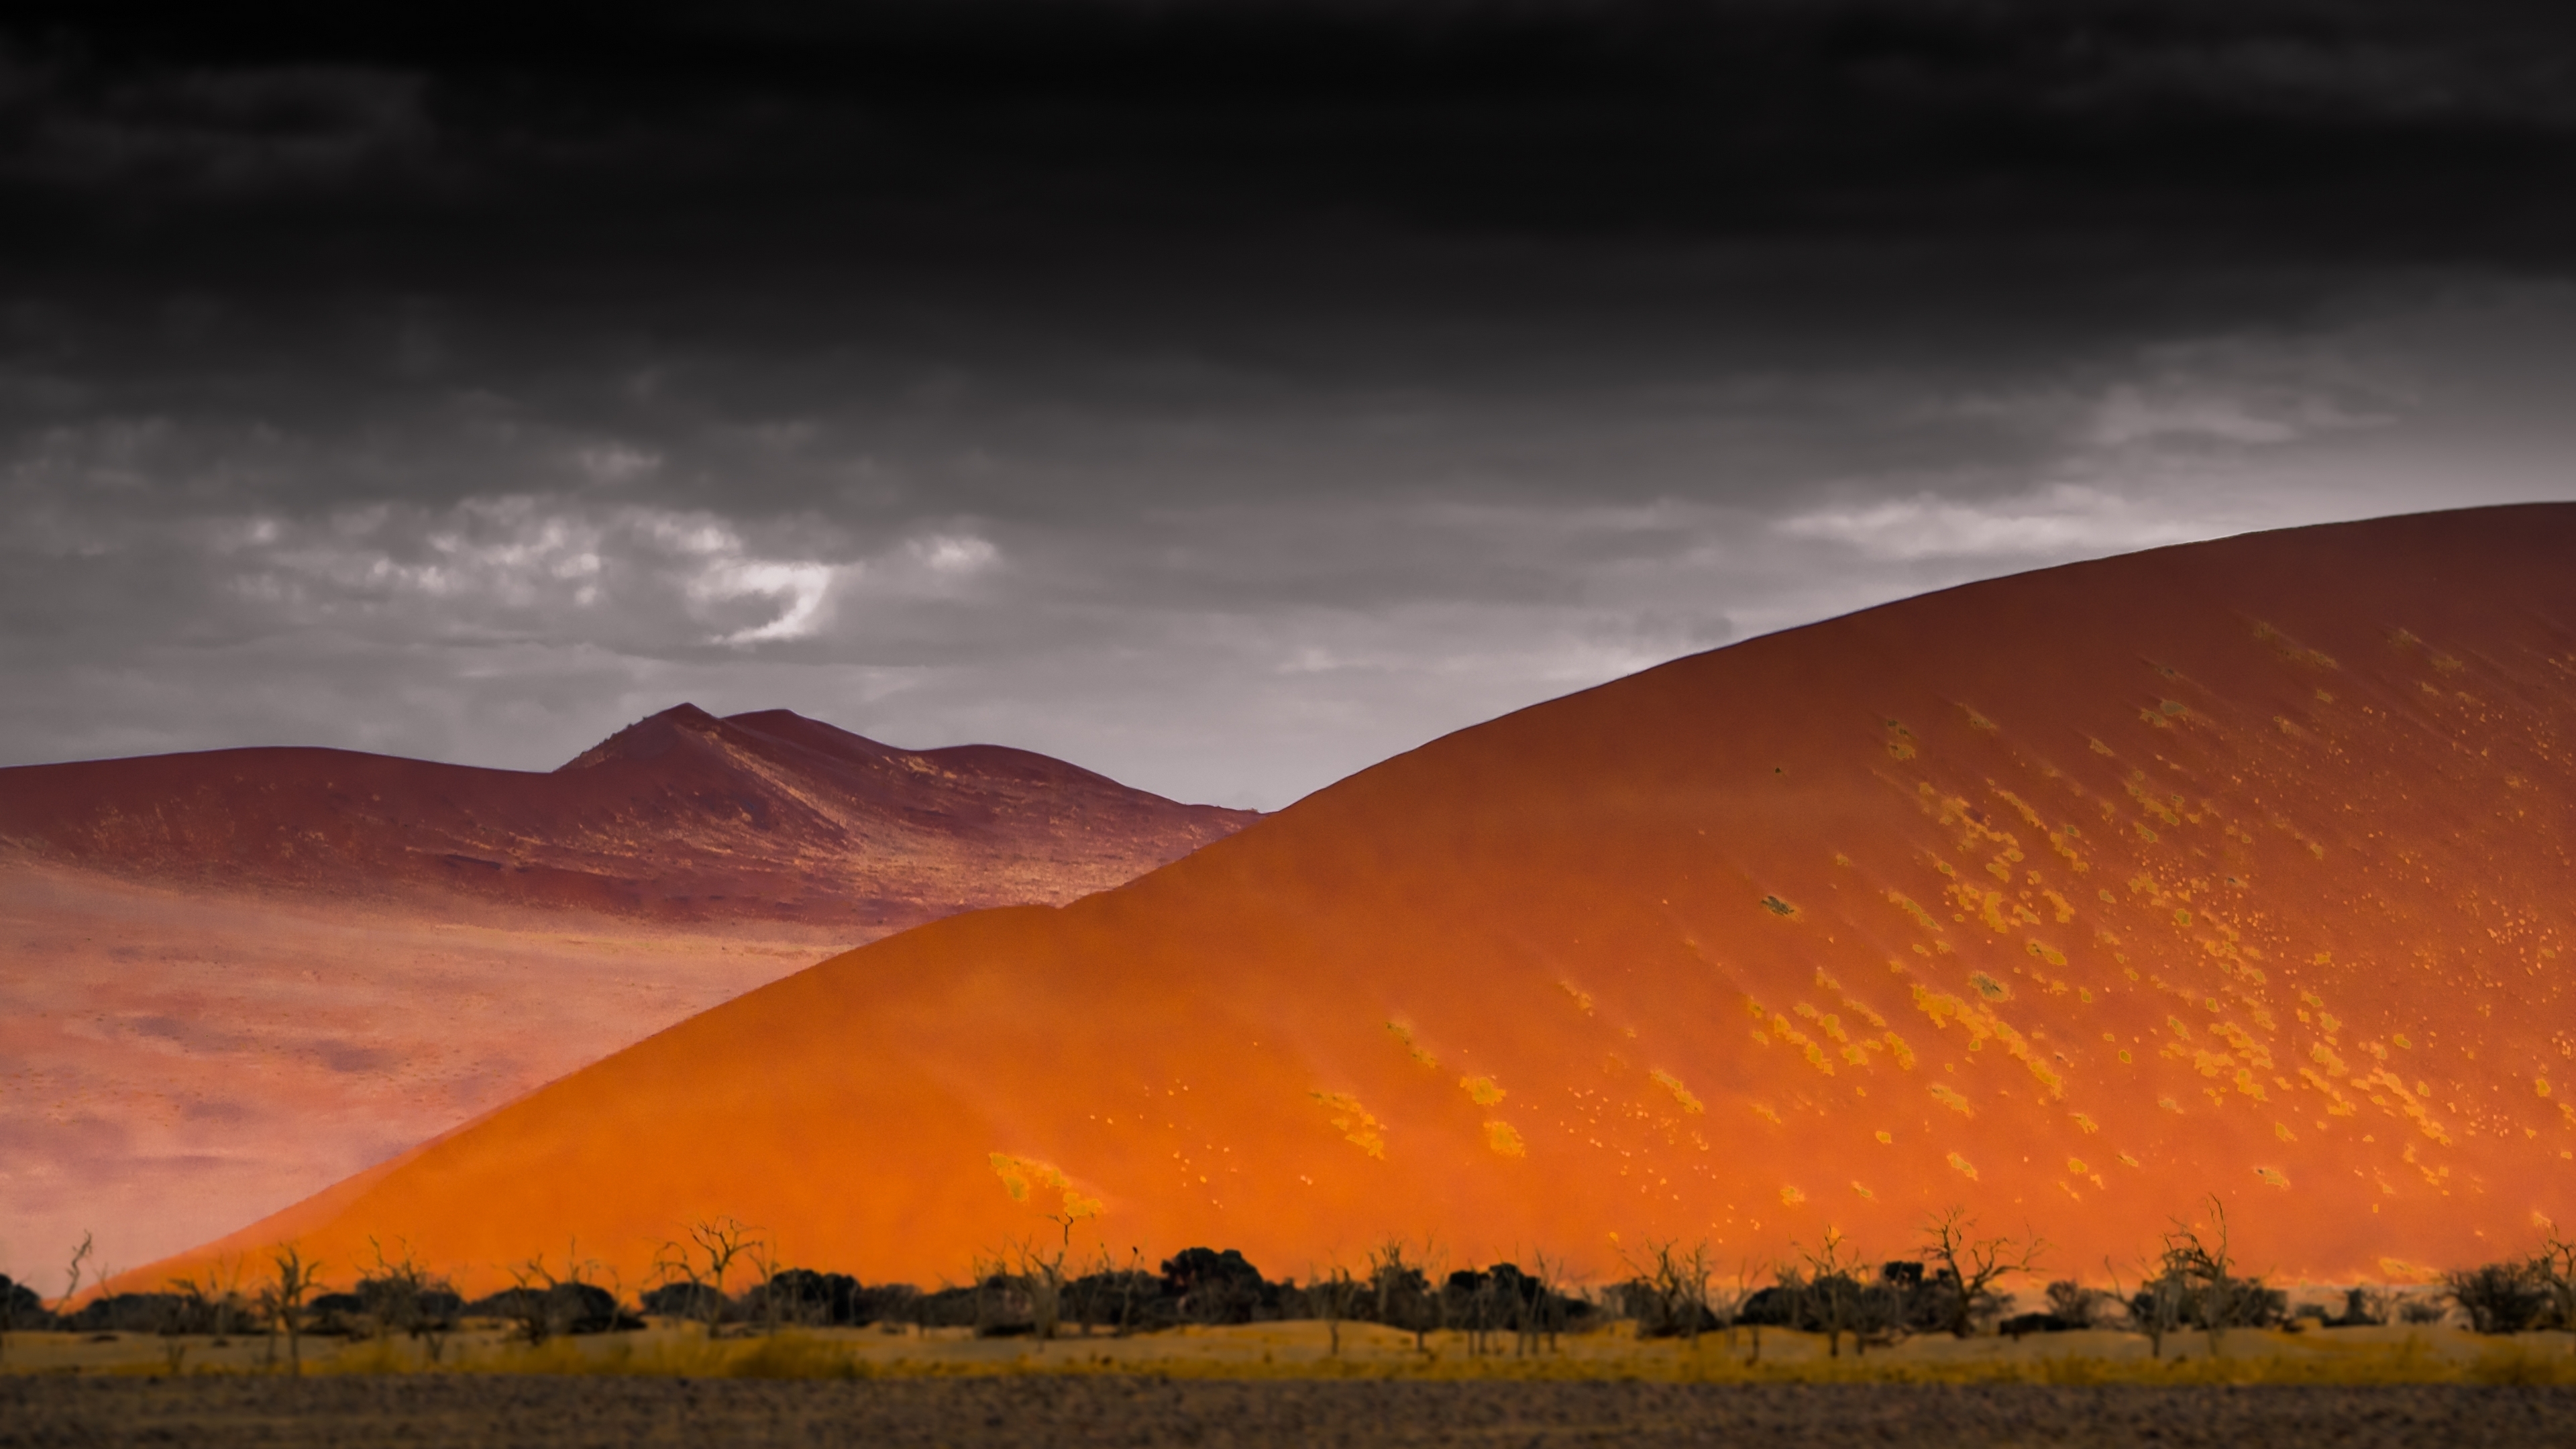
[0,1377,2576,1449]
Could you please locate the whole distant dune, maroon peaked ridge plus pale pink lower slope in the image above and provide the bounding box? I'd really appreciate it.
[0,706,1254,1281]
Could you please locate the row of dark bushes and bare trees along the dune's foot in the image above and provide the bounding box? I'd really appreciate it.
[15,1199,2576,1372]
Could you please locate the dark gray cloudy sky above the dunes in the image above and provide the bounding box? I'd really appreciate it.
[0,0,2576,807]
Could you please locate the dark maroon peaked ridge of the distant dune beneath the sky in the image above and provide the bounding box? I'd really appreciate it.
[0,704,1254,936]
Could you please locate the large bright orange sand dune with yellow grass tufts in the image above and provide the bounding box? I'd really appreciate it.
[146,505,2576,1281]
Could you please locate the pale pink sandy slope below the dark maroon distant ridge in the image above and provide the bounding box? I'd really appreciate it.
[0,859,865,1273]
